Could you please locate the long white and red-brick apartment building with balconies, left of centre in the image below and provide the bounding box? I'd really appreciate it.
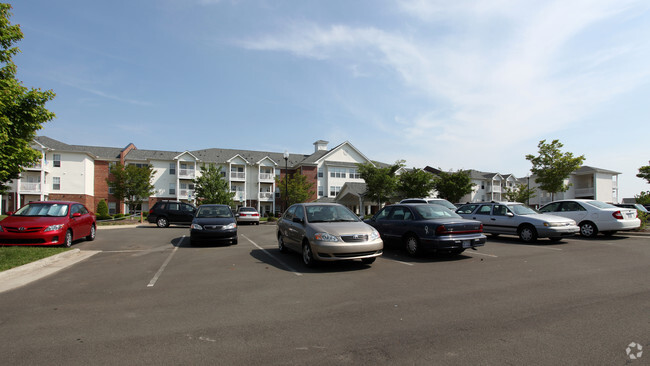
[0,136,374,217]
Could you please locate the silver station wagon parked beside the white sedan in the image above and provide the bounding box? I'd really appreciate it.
[456,202,580,243]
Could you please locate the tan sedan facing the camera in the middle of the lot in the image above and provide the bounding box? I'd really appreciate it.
[277,203,384,267]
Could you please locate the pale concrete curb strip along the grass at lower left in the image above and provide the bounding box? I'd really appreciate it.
[0,249,101,293]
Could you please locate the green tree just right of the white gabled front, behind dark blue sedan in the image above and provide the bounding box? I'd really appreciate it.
[357,160,404,206]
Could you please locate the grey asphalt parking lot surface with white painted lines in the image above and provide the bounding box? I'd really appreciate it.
[0,225,650,365]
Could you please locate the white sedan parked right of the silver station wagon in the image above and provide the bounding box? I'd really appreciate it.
[539,199,641,238]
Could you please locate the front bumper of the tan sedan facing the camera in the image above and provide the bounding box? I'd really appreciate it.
[311,239,384,261]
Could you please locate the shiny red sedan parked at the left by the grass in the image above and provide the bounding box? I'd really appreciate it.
[0,201,97,247]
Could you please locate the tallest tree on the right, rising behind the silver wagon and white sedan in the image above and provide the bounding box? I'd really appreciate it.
[526,140,585,199]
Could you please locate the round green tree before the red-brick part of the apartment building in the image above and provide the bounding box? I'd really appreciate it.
[106,164,154,212]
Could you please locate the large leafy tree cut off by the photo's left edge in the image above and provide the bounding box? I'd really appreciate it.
[0,4,55,193]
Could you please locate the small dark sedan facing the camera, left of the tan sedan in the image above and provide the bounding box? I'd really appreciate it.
[190,205,237,245]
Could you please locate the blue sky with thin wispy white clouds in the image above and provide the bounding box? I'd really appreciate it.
[11,0,650,197]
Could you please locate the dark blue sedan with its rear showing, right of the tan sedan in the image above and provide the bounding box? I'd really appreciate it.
[366,204,486,256]
